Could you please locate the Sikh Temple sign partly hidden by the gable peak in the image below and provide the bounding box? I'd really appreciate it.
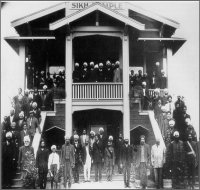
[69,2,124,10]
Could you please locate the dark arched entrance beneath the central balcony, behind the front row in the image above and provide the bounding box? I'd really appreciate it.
[73,109,123,141]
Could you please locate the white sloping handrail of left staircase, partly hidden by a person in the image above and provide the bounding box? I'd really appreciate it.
[32,111,47,158]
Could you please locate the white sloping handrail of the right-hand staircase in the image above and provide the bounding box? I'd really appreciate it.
[147,111,166,148]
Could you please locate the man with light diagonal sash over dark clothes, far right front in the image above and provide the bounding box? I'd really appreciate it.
[184,134,198,189]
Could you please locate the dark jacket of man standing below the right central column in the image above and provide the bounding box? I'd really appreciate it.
[121,145,133,165]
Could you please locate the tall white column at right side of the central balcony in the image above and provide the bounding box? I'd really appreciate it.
[122,36,130,141]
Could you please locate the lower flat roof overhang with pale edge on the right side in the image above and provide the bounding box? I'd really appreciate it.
[138,37,186,54]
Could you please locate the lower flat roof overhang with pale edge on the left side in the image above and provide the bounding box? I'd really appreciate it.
[4,36,56,54]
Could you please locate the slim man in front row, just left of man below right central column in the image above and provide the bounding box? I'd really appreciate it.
[116,133,124,174]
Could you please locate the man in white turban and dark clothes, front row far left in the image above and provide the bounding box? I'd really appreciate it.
[1,132,16,189]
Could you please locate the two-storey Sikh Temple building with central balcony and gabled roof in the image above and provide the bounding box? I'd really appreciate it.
[1,2,195,149]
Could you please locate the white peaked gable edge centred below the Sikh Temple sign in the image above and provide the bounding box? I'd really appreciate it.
[49,2,145,30]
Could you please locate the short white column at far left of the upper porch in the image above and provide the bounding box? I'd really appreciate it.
[19,43,26,91]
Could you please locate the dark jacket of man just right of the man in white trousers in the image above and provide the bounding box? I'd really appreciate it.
[92,141,103,163]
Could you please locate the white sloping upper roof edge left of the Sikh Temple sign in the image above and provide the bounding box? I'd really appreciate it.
[11,2,66,27]
